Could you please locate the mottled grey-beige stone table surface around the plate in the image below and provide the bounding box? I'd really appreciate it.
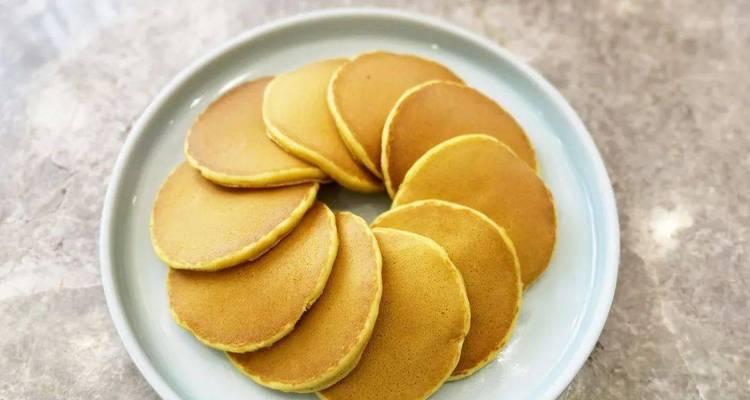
[0,0,750,399]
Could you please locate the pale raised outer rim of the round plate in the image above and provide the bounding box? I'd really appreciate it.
[99,7,620,400]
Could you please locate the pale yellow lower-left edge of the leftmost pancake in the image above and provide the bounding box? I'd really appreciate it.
[149,164,320,271]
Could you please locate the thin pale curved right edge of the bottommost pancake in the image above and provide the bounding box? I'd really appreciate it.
[315,227,471,400]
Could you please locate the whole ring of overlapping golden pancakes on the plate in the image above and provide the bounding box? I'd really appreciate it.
[150,51,556,399]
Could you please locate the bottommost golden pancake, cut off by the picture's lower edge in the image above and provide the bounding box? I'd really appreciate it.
[318,228,471,400]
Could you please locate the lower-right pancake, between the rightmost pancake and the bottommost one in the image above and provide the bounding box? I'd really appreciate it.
[372,200,523,379]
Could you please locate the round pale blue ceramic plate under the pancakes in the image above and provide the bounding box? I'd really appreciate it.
[100,10,620,400]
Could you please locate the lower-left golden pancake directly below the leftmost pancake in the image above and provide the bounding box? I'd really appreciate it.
[167,203,338,353]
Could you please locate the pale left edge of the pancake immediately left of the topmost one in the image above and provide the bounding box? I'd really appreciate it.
[263,69,383,193]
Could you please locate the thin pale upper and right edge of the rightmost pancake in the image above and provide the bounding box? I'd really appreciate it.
[391,133,558,292]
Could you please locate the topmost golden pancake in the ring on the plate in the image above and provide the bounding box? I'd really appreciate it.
[328,51,461,177]
